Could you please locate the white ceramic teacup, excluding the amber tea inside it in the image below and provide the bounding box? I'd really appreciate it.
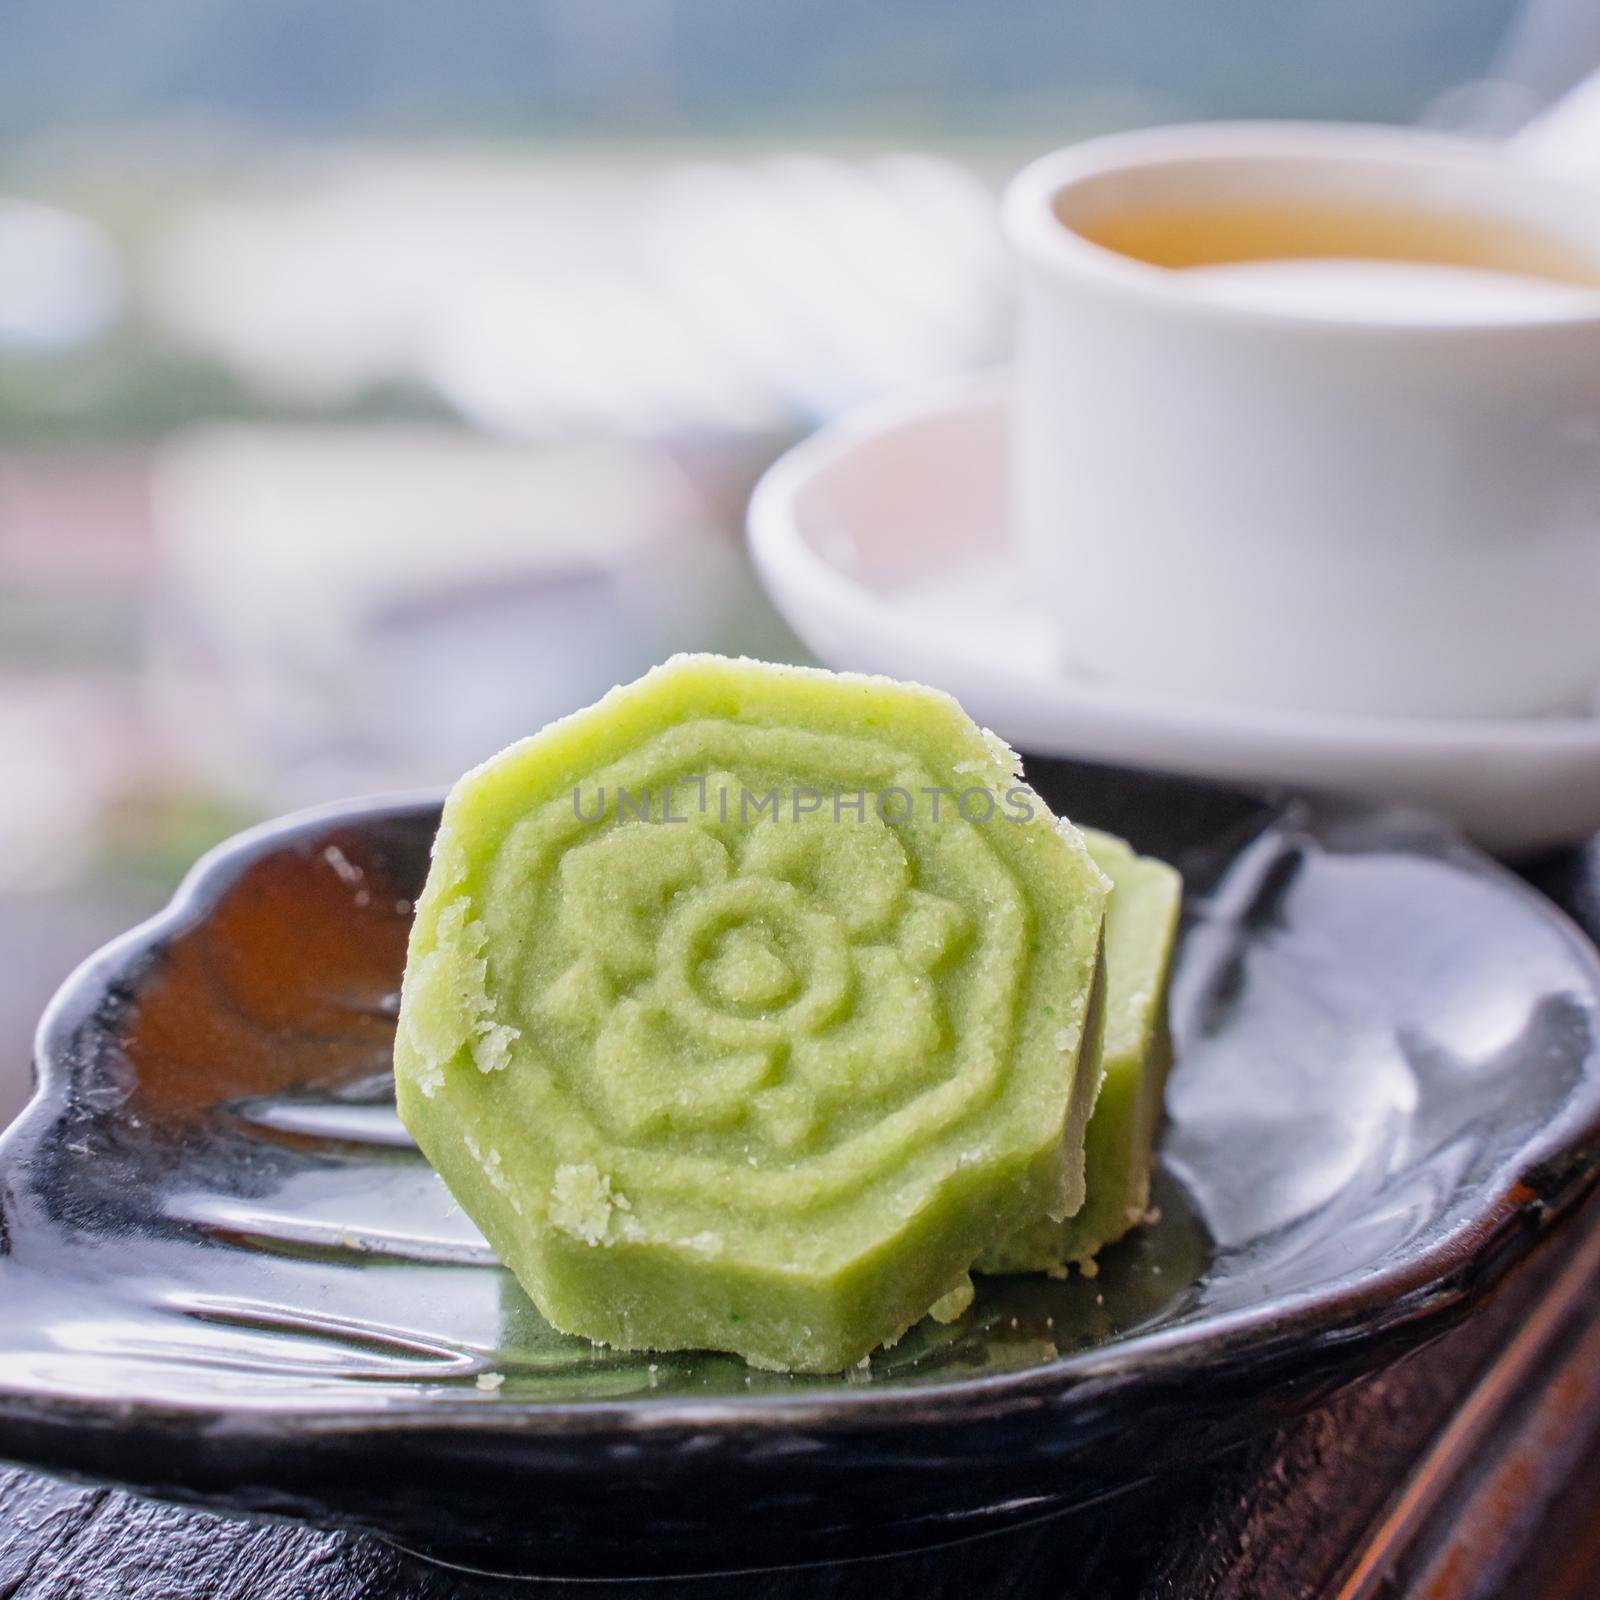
[1005,123,1600,717]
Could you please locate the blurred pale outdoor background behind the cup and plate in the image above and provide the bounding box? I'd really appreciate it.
[0,0,1600,1123]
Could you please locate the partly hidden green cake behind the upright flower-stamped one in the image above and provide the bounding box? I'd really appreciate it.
[976,827,1182,1272]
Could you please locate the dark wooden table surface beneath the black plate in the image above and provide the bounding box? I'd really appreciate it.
[9,843,1600,1600]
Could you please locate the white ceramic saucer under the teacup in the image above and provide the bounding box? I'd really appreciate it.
[750,376,1600,851]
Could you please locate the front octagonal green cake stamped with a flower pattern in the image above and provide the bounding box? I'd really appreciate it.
[395,656,1106,1371]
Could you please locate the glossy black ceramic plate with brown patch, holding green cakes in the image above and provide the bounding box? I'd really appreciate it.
[0,763,1600,1573]
